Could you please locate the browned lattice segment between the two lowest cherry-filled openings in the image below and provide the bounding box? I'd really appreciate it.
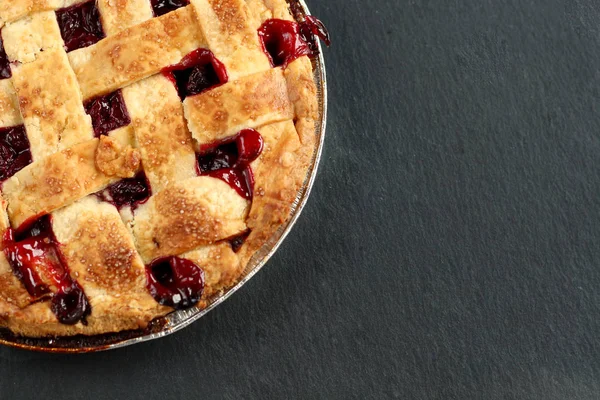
[52,196,170,333]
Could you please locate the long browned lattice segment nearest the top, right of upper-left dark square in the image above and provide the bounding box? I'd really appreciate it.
[69,6,204,99]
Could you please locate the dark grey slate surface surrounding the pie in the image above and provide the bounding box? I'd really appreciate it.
[0,0,600,400]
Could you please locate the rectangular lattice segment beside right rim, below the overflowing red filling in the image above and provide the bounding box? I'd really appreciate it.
[183,68,294,144]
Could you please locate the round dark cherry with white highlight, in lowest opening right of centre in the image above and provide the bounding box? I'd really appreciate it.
[146,256,204,310]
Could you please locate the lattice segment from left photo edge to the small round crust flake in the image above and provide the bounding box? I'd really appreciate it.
[3,139,135,228]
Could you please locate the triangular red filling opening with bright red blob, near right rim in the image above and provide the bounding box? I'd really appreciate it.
[197,129,264,200]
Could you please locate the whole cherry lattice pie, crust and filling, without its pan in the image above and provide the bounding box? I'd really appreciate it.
[0,0,328,337]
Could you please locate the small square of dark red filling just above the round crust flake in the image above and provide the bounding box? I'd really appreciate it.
[84,90,131,137]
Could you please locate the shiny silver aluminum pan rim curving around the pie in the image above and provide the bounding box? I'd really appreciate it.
[0,0,327,353]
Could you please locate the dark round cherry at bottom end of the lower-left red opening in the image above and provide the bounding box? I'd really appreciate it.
[50,282,92,325]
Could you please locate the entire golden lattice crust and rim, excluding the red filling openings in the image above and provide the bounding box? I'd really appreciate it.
[0,0,318,337]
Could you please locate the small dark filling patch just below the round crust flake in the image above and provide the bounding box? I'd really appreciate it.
[98,172,152,209]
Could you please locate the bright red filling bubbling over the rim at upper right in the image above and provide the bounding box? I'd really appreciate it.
[258,15,331,68]
